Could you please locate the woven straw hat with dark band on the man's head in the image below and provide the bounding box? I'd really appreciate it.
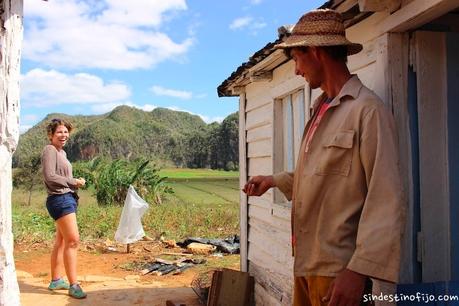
[275,9,363,55]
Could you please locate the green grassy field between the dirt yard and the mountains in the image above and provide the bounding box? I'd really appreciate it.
[12,169,239,242]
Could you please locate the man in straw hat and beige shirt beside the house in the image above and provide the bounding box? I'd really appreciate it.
[244,10,404,306]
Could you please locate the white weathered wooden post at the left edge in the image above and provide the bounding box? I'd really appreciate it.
[0,0,23,306]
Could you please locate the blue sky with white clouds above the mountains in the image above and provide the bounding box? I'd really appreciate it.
[20,0,325,133]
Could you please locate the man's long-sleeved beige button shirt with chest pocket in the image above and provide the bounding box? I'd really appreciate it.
[274,76,405,282]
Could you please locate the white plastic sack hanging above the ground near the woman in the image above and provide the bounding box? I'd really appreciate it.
[115,186,148,244]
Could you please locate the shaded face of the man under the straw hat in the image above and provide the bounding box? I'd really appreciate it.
[290,47,322,89]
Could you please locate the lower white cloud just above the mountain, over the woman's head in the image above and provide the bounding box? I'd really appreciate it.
[21,69,131,107]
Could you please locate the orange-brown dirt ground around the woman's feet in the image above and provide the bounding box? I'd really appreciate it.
[15,241,239,306]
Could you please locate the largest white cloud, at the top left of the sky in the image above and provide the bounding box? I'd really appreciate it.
[23,0,193,69]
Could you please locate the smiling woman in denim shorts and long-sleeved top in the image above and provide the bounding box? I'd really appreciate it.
[41,119,86,299]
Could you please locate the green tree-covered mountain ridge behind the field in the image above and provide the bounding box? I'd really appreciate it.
[13,106,238,168]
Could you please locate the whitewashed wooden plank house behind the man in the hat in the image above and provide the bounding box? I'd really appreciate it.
[218,0,459,305]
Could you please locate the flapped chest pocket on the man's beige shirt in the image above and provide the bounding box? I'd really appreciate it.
[315,130,355,176]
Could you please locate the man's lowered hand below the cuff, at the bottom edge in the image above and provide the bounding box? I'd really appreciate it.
[323,269,367,306]
